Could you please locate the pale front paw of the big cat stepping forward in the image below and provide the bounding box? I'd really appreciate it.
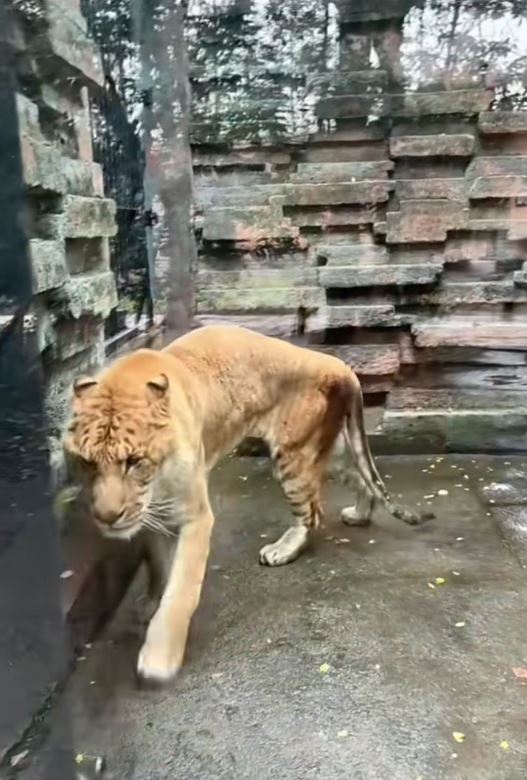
[137,618,185,683]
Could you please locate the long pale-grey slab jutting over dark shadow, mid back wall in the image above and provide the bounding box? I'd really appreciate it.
[320,263,443,288]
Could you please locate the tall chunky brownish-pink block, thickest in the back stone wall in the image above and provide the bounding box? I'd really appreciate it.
[386,200,469,244]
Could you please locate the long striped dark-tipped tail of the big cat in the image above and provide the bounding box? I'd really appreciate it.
[344,389,434,525]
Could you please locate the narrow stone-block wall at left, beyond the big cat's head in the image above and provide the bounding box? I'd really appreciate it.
[9,0,116,470]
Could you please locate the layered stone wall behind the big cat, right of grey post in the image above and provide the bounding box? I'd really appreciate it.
[188,0,527,452]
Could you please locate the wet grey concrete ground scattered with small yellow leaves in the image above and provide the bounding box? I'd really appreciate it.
[27,457,527,780]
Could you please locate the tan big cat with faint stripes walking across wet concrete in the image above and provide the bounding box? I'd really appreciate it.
[64,326,428,680]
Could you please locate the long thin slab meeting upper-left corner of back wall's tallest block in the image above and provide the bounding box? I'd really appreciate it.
[284,181,392,206]
